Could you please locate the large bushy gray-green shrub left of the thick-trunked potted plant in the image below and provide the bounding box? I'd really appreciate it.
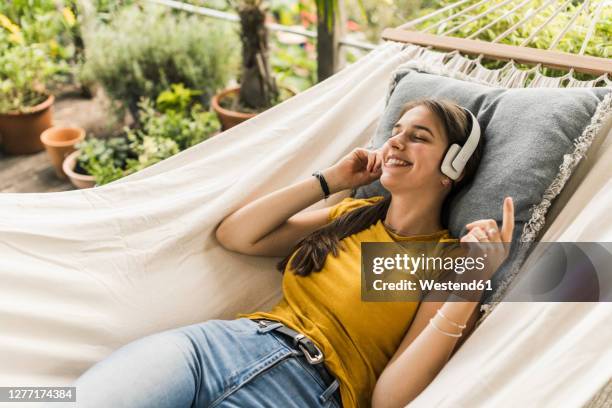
[83,6,238,116]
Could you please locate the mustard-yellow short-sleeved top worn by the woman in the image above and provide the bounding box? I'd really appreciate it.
[238,196,457,408]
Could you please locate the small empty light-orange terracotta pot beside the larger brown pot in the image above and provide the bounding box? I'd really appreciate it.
[40,126,85,179]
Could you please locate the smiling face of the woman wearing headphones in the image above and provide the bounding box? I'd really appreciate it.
[380,105,448,193]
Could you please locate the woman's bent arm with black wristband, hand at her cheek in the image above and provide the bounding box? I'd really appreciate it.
[216,148,381,256]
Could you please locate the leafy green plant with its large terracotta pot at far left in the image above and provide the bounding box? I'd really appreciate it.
[0,44,59,154]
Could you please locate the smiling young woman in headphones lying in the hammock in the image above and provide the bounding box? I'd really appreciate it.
[65,99,514,408]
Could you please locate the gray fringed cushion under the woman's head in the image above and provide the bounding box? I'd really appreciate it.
[353,70,610,302]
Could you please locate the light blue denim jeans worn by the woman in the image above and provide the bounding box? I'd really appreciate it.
[62,318,340,408]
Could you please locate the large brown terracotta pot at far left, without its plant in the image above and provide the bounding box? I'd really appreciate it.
[0,95,55,154]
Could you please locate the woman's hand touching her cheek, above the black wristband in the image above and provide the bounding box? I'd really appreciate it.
[323,147,382,192]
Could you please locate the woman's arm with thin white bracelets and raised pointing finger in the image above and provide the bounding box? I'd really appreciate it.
[372,198,514,408]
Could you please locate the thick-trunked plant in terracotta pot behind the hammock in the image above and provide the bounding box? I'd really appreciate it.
[211,0,295,130]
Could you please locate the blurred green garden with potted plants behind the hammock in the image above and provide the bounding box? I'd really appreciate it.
[0,0,612,192]
